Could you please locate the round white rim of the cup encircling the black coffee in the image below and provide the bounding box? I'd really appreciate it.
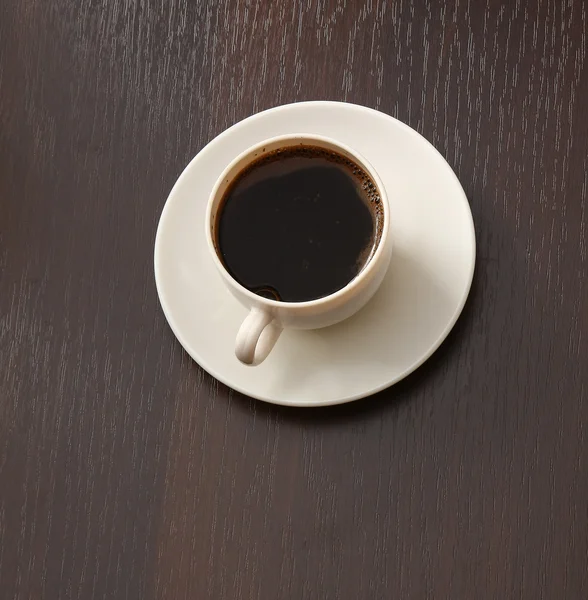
[205,133,390,309]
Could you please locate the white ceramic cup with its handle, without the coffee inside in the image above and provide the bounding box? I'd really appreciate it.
[206,134,392,365]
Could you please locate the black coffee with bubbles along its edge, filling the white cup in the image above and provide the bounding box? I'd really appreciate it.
[216,146,383,302]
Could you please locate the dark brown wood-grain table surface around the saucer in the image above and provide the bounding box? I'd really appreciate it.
[0,0,588,600]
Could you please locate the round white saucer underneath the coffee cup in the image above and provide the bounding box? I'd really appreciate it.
[155,102,475,406]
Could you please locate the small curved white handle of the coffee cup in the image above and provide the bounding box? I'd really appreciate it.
[235,308,282,365]
